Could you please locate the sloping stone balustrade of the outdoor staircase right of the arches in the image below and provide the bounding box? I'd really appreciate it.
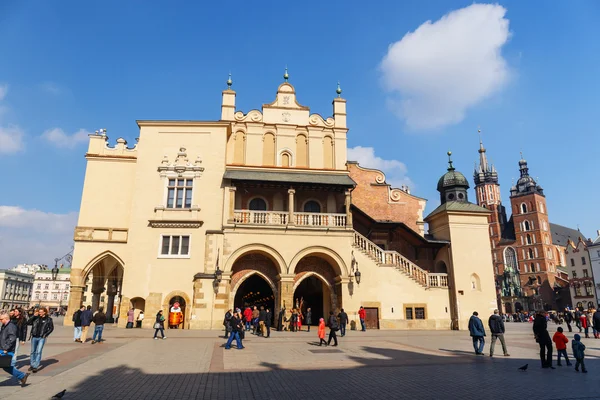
[352,231,448,289]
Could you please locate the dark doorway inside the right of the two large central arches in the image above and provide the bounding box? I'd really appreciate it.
[294,275,331,325]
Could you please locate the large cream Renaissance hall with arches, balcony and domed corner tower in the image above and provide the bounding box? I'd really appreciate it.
[65,73,496,329]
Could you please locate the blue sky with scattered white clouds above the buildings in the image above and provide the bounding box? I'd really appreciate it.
[0,0,600,268]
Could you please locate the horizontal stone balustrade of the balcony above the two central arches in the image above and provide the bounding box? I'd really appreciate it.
[233,210,348,228]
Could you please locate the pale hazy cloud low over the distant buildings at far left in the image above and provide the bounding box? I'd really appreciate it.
[0,206,77,268]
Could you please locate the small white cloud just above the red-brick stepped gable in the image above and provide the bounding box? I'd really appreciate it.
[347,146,414,189]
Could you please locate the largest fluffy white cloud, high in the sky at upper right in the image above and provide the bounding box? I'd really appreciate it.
[381,4,510,130]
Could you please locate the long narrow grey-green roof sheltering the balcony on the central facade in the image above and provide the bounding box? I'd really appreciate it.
[223,170,356,186]
